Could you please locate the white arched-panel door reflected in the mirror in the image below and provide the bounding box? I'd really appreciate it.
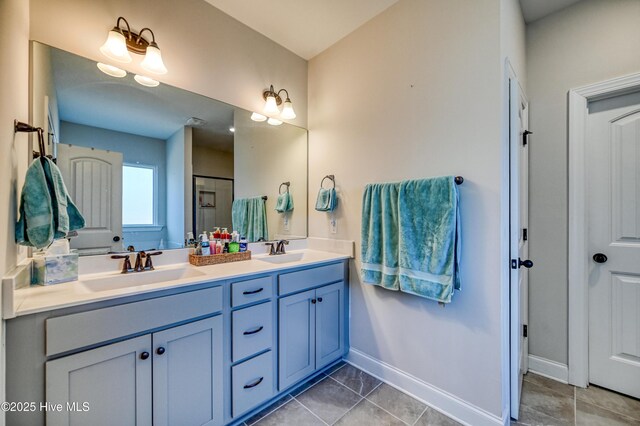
[57,144,122,254]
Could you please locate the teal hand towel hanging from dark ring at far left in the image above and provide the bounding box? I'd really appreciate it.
[16,157,85,248]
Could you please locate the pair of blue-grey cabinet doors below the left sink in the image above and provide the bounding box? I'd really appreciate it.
[46,315,222,426]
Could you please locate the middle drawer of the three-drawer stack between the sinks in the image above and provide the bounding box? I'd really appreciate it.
[231,302,273,362]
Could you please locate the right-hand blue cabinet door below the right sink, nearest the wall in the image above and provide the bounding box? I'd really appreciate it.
[316,282,344,369]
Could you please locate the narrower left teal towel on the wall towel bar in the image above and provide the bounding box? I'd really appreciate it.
[361,183,400,290]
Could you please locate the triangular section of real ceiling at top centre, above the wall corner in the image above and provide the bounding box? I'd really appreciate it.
[205,0,398,59]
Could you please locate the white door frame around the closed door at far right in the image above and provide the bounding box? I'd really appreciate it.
[567,73,640,387]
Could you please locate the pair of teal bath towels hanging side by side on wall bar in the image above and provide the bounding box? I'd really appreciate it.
[361,176,461,303]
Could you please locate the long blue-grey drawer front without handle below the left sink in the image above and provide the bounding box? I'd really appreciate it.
[46,286,222,356]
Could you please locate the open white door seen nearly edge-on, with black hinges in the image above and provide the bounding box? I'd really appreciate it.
[509,79,532,419]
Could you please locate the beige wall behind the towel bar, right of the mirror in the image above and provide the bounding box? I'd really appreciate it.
[309,0,504,417]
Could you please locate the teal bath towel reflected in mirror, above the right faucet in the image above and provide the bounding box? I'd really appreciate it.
[231,197,269,242]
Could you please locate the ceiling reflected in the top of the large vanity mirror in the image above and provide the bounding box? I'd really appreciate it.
[51,48,235,152]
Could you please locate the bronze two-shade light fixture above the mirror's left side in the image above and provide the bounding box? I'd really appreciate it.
[100,16,167,74]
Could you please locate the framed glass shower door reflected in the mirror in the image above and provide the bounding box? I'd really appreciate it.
[193,175,238,238]
